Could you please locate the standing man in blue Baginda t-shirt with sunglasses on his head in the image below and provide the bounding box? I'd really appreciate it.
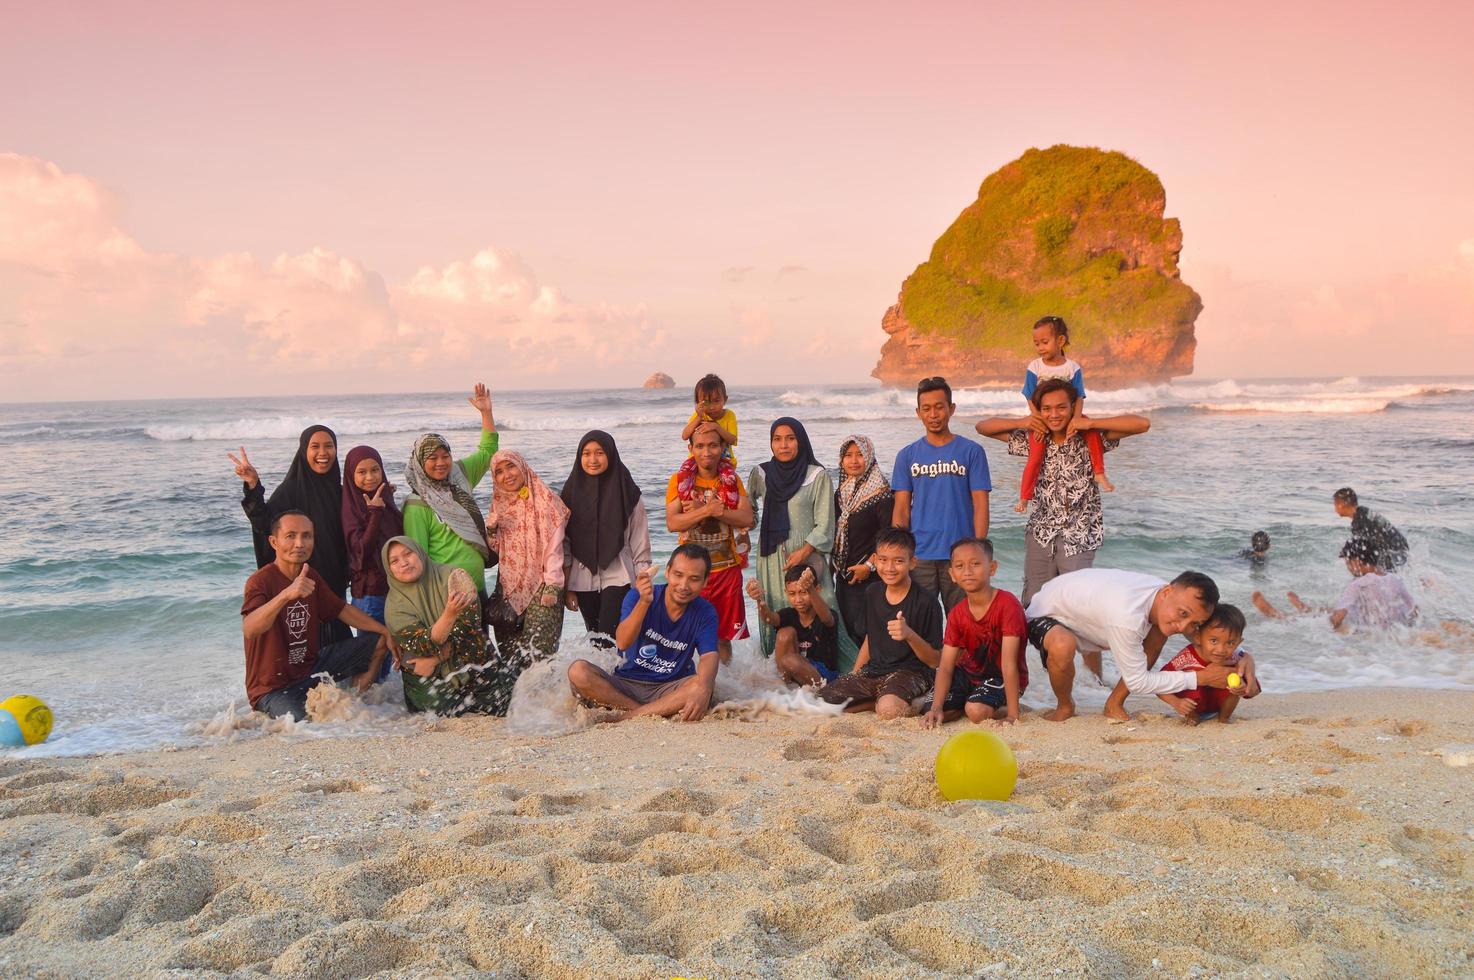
[890,377,993,610]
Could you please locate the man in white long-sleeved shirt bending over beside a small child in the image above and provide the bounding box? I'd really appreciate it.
[1027,569,1231,721]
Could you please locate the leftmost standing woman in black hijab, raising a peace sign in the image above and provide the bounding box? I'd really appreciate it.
[227,426,352,643]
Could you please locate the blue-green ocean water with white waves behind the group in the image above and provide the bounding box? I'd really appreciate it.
[0,377,1474,756]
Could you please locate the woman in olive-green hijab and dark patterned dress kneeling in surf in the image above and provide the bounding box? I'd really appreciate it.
[382,536,528,715]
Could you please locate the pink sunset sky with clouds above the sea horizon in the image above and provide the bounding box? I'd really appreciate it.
[0,0,1474,401]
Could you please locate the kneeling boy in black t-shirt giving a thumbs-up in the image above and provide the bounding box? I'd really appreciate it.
[820,528,942,718]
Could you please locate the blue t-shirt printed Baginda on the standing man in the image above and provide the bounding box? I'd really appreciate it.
[890,436,993,560]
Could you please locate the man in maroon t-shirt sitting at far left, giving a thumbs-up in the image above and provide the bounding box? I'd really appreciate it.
[240,510,394,721]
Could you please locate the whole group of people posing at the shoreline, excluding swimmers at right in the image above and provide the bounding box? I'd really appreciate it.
[231,317,1415,725]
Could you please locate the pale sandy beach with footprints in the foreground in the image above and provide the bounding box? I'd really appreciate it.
[0,691,1474,977]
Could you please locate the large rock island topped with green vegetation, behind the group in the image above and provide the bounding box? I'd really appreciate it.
[871,146,1203,389]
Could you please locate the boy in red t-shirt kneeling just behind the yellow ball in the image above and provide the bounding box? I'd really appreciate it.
[921,538,1029,728]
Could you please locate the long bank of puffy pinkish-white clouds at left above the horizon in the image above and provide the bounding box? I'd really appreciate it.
[0,153,651,398]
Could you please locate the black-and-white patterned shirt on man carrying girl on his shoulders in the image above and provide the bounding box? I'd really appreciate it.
[1008,429,1120,556]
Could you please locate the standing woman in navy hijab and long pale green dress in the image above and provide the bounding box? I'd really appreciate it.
[747,417,834,657]
